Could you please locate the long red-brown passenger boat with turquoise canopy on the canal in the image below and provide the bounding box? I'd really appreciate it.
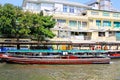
[4,50,110,64]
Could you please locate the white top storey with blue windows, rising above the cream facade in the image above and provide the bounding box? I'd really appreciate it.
[23,0,90,14]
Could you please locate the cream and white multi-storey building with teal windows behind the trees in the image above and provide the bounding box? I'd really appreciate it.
[23,0,120,42]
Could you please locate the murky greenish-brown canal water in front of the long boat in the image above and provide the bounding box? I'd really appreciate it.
[0,59,120,80]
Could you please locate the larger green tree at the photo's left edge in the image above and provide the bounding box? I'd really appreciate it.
[0,4,30,48]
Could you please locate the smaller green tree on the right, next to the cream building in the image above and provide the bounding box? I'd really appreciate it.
[31,12,56,42]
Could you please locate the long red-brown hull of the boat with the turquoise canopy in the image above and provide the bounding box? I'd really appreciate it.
[6,57,110,64]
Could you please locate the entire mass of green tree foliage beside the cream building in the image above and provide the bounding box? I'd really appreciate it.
[0,4,55,40]
